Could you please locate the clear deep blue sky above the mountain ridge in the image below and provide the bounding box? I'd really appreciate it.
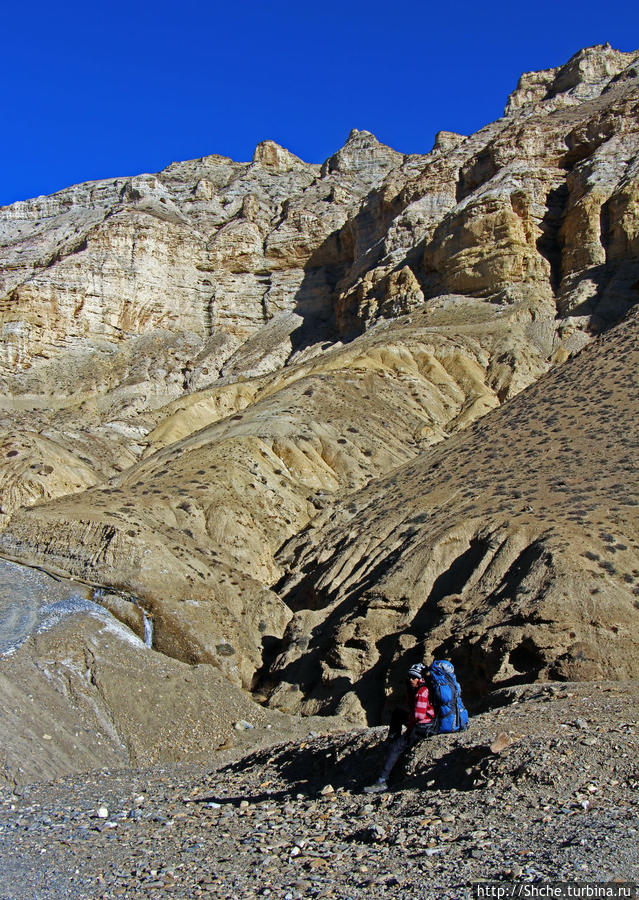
[0,0,639,205]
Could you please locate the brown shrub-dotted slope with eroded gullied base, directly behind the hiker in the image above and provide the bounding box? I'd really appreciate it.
[269,311,639,721]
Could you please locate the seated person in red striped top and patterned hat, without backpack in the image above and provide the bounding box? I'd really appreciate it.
[364,664,439,794]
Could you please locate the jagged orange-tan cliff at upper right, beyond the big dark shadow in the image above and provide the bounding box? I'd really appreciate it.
[336,47,639,329]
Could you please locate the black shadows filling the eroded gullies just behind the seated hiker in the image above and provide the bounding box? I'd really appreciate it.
[256,535,548,725]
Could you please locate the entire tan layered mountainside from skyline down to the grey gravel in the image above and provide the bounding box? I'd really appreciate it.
[0,46,639,719]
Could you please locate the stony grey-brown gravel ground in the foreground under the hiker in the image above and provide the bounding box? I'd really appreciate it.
[0,682,639,900]
